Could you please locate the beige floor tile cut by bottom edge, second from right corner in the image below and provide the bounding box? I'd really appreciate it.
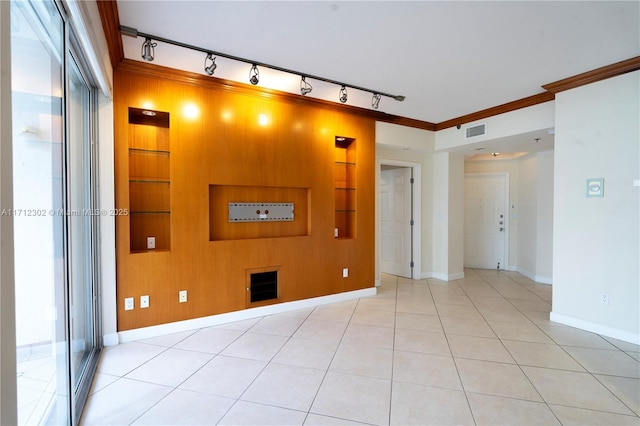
[467,393,560,426]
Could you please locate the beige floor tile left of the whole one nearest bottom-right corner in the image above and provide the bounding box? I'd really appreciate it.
[456,359,542,402]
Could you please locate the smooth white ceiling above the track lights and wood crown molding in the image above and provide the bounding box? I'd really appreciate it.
[112,0,640,153]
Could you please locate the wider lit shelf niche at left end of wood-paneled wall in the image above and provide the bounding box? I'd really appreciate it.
[129,108,171,253]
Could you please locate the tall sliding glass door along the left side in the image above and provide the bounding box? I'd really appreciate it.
[10,1,101,424]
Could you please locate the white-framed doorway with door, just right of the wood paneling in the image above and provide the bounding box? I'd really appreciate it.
[378,160,421,279]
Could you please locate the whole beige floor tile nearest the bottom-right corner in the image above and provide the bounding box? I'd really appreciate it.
[522,367,633,415]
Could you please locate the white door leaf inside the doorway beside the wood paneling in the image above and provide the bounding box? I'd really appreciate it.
[380,167,412,278]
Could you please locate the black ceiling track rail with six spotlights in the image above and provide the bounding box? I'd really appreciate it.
[120,25,405,109]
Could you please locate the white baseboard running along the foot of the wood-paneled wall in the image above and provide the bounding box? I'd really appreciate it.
[115,287,377,346]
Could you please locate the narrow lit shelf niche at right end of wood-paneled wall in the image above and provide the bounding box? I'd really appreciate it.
[334,136,356,239]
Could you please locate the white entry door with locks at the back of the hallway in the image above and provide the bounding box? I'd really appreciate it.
[464,174,508,269]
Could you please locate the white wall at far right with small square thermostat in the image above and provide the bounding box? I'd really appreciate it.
[551,71,640,344]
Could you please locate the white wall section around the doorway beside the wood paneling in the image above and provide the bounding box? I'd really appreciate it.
[375,122,434,280]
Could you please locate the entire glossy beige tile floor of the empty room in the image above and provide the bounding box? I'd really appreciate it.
[81,270,640,425]
